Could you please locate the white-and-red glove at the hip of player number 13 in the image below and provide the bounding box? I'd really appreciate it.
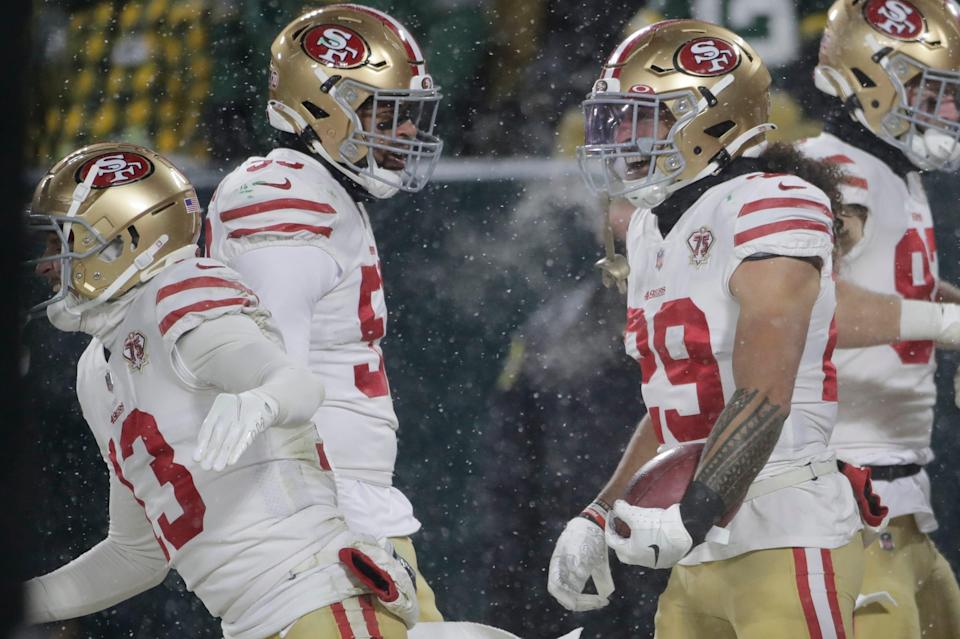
[339,538,420,628]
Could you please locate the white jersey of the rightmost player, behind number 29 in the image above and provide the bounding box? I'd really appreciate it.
[800,133,939,531]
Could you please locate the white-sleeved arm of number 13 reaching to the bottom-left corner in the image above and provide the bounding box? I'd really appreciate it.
[26,472,169,623]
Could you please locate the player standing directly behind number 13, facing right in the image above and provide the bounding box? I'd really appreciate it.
[206,4,442,621]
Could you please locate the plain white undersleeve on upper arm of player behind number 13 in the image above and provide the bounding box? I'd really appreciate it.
[231,246,342,366]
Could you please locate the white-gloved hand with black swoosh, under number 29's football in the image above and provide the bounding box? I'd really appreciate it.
[606,500,693,568]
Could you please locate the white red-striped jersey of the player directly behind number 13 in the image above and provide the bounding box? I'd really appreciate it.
[206,148,420,536]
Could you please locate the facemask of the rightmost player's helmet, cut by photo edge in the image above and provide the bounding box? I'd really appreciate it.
[879,54,960,171]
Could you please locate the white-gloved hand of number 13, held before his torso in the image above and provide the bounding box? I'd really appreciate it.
[193,391,277,471]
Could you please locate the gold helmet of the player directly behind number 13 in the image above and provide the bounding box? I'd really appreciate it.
[267,4,443,198]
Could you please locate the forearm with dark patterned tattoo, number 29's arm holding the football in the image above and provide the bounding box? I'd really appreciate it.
[694,389,788,504]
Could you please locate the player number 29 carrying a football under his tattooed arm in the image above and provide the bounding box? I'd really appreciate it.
[548,20,863,639]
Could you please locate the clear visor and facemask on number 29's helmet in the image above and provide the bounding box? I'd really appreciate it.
[577,92,694,197]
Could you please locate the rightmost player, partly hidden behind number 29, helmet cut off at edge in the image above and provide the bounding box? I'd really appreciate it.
[801,0,960,638]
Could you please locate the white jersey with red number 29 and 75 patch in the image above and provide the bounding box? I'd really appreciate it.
[625,173,860,565]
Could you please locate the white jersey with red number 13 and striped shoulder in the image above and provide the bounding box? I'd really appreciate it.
[77,259,359,639]
